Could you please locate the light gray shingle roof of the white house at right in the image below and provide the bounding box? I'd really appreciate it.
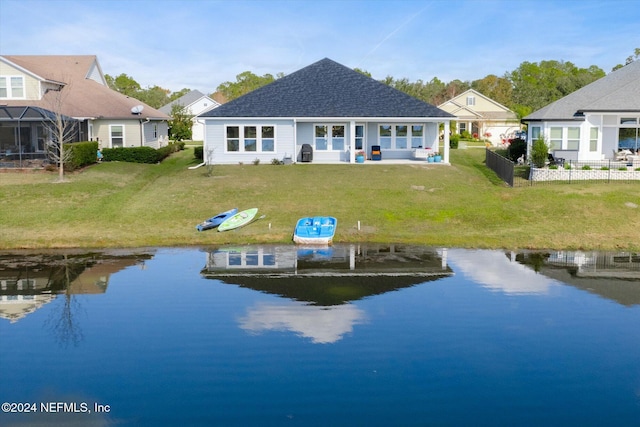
[523,61,640,121]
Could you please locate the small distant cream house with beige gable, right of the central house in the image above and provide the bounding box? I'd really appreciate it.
[438,89,520,145]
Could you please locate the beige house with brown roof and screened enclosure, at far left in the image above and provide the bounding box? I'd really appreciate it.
[0,55,170,158]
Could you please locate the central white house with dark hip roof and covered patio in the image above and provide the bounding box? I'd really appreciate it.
[198,58,455,164]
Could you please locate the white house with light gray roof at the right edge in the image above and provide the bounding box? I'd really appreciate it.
[522,61,640,161]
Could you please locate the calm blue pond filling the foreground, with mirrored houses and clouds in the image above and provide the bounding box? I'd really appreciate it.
[0,245,640,426]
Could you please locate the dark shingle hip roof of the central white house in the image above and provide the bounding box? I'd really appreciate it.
[200,58,455,118]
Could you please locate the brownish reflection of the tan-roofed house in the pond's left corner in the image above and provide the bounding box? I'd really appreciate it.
[0,253,151,322]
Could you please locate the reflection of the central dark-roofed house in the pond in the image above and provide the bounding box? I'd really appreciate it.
[202,245,453,306]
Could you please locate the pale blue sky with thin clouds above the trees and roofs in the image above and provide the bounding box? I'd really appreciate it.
[0,0,640,94]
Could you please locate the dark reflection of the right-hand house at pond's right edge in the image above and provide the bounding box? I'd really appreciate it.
[517,251,640,306]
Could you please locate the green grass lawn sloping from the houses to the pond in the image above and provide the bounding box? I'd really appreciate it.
[0,148,640,250]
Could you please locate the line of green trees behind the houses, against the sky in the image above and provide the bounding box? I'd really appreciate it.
[105,48,640,118]
